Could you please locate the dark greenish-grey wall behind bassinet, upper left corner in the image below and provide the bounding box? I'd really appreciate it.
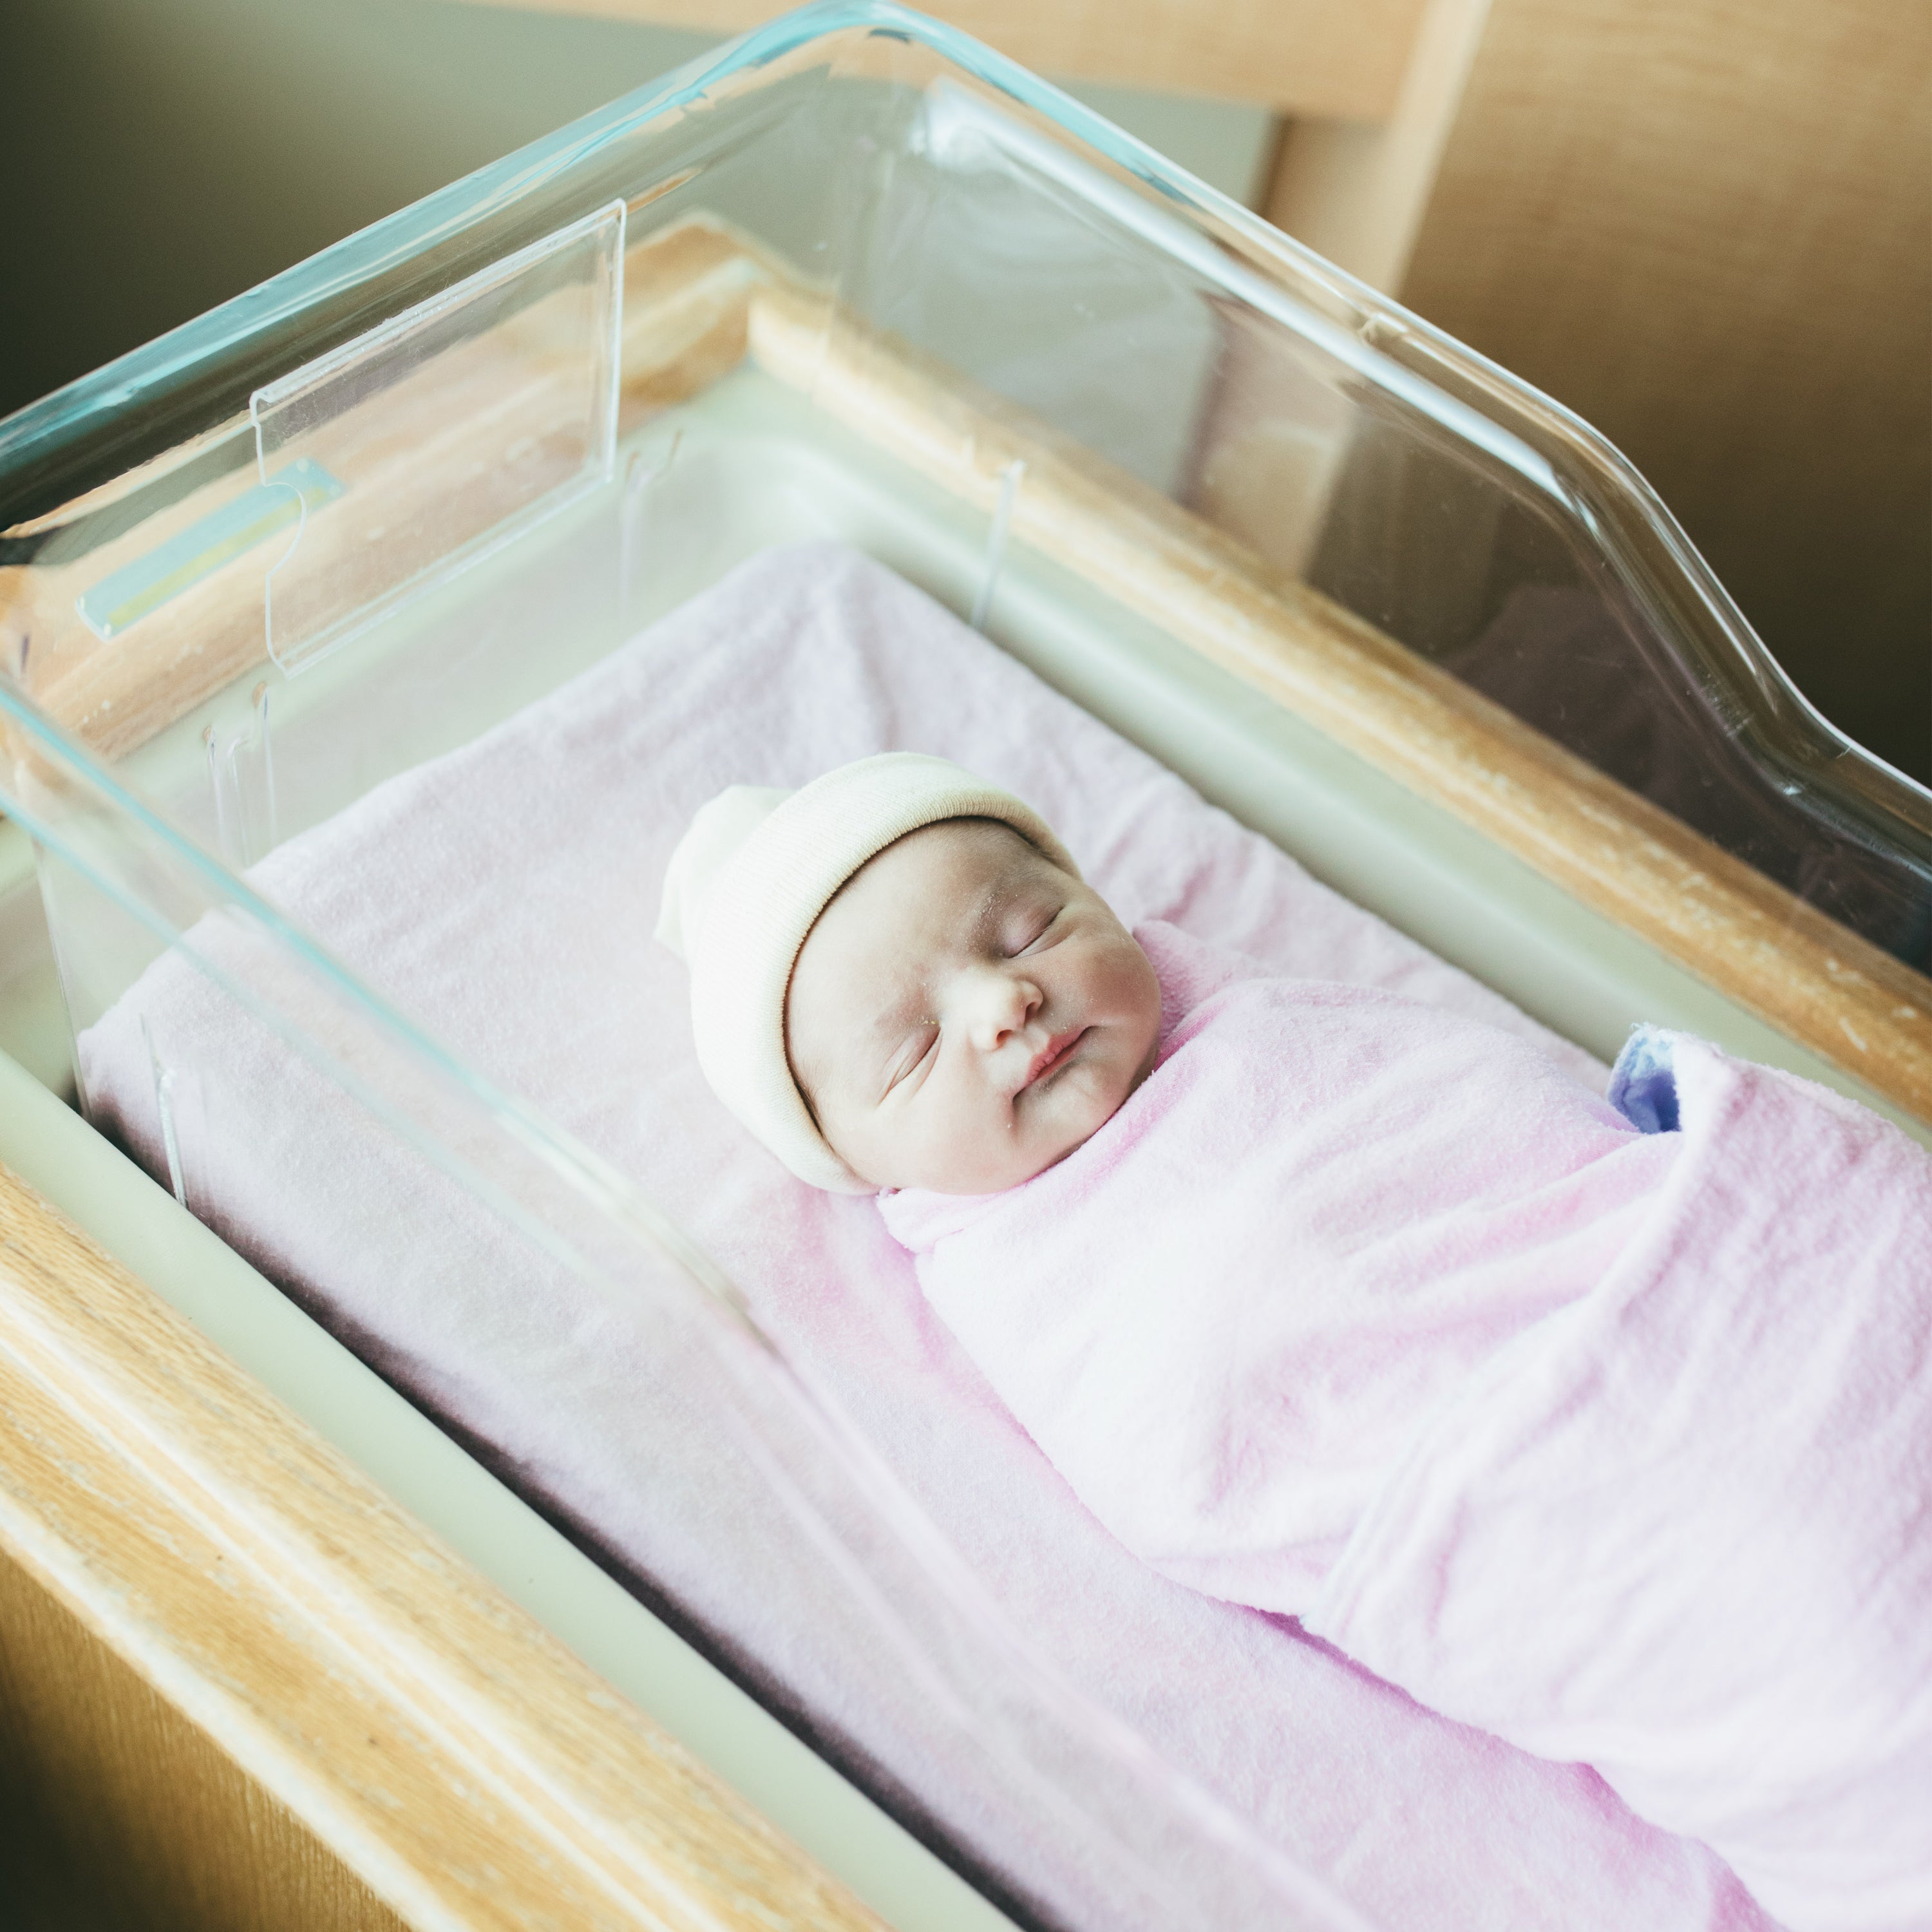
[0,0,711,413]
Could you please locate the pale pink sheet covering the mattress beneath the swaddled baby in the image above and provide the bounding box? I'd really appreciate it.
[81,547,1768,1932]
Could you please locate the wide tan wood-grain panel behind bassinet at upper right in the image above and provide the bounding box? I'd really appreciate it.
[1399,0,1932,781]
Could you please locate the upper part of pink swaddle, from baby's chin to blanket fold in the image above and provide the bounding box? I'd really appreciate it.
[879,923,1677,1615]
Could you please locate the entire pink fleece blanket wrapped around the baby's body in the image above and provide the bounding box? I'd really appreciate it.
[879,923,1932,1932]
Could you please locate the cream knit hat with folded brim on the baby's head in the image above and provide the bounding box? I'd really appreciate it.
[657,752,1080,1194]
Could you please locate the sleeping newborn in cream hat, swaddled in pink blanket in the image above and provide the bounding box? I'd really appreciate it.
[659,753,1932,1928]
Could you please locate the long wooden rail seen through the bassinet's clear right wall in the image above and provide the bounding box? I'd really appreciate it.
[752,288,1932,1121]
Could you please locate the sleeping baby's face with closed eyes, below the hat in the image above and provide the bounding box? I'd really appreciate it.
[784,819,1161,1194]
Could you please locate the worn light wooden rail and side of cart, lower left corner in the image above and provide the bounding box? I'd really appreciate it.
[0,1167,879,1932]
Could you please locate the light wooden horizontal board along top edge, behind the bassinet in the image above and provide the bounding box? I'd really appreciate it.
[444,0,1426,120]
